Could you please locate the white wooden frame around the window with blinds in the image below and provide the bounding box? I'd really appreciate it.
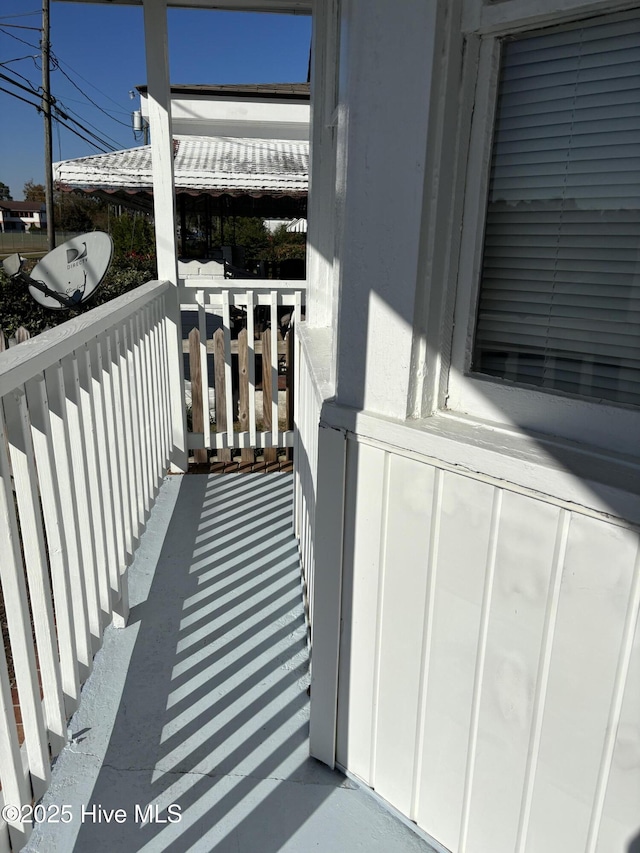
[439,0,640,457]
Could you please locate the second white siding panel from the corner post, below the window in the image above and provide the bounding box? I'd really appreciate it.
[373,456,435,814]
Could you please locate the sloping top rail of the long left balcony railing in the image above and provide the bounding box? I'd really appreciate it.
[0,281,173,397]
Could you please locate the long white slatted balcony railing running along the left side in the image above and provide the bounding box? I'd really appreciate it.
[0,282,184,851]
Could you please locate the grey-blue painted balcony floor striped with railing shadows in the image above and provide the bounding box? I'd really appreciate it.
[24,474,432,853]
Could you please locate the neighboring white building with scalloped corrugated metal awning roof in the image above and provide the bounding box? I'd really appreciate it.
[54,83,310,258]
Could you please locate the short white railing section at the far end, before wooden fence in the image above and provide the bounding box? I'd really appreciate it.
[179,278,306,462]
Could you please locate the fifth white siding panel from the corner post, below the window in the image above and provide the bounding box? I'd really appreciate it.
[525,515,637,853]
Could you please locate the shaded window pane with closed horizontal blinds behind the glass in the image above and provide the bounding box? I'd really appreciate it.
[471,18,640,405]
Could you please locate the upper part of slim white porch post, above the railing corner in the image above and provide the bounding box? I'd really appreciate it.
[144,0,178,285]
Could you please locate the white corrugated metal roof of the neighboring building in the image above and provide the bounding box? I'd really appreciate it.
[54,136,309,195]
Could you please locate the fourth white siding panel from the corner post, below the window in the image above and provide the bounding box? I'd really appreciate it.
[466,492,560,851]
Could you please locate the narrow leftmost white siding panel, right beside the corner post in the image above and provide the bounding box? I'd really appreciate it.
[336,441,385,784]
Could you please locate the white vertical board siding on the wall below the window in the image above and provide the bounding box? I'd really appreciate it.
[336,440,640,853]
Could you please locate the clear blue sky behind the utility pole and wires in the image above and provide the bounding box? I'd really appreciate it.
[0,0,311,199]
